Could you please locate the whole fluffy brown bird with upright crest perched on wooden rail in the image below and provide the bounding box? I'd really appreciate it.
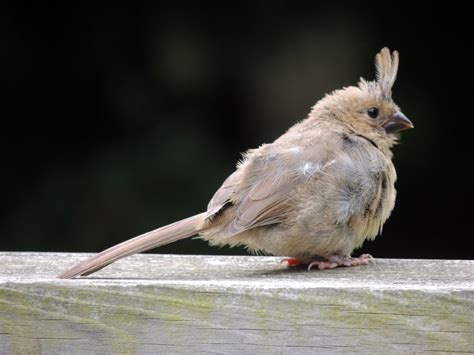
[59,48,413,278]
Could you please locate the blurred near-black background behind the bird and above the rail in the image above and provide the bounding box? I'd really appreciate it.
[0,1,474,258]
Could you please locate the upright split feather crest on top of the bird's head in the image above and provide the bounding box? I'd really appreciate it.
[359,47,399,100]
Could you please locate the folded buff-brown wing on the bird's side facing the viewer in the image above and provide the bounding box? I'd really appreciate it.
[207,140,334,237]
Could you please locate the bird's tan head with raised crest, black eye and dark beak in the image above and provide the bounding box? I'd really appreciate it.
[314,48,413,148]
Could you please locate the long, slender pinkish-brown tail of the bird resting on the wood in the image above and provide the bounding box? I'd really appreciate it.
[58,213,206,279]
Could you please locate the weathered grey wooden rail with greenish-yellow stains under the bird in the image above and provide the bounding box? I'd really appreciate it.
[0,253,474,354]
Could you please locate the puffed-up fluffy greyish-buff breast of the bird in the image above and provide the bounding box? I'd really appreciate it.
[301,141,396,253]
